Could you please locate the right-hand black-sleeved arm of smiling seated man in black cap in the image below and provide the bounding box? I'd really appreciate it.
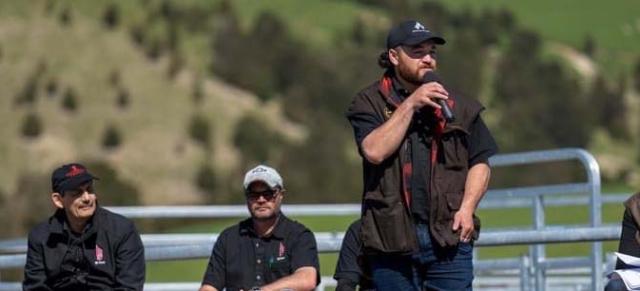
[115,222,145,290]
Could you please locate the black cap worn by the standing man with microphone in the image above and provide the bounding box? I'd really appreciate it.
[387,20,446,49]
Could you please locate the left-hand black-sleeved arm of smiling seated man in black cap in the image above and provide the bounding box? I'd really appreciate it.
[22,233,51,291]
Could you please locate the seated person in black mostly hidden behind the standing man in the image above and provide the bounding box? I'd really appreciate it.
[333,219,374,291]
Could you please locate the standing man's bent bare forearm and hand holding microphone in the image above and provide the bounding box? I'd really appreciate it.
[361,82,448,165]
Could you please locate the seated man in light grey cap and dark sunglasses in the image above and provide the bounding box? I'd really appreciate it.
[200,165,320,291]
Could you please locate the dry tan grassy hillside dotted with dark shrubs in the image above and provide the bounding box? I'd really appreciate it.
[0,1,300,204]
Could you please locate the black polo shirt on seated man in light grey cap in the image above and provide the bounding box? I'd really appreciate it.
[202,214,320,291]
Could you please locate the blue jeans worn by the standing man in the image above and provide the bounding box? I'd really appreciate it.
[371,224,473,291]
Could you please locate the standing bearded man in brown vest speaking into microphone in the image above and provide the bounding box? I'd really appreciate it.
[347,20,497,290]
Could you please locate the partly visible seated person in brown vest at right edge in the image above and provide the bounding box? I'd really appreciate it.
[605,193,640,291]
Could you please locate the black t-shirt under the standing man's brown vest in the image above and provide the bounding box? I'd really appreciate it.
[349,78,498,222]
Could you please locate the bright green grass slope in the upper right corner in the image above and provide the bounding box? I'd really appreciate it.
[441,0,640,74]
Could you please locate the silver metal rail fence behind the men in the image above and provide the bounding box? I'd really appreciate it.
[0,149,628,290]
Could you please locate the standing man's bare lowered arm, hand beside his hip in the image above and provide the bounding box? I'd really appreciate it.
[453,163,491,242]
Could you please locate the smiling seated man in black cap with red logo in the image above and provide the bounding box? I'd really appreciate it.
[23,164,145,290]
